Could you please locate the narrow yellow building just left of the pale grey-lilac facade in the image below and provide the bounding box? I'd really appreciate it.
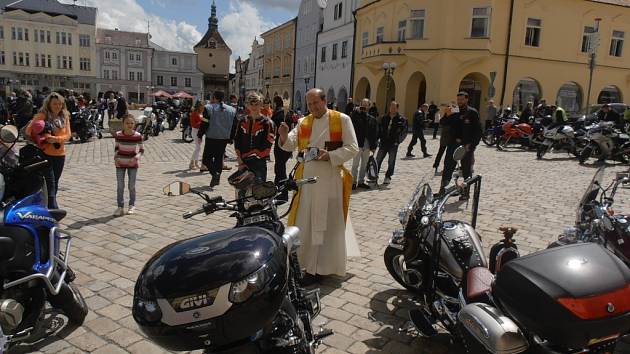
[261,18,297,105]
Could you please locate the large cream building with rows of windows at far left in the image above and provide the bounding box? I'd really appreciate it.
[0,0,97,95]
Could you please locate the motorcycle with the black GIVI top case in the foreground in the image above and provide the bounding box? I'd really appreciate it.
[132,176,332,354]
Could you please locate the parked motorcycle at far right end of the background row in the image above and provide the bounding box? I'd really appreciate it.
[578,121,630,164]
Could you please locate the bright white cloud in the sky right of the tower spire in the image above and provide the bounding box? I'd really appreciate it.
[219,0,276,71]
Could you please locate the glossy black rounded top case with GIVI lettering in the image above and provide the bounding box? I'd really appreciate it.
[137,227,288,352]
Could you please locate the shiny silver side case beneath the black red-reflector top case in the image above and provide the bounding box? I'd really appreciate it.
[457,303,529,354]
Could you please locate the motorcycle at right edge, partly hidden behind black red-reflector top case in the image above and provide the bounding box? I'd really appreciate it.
[549,166,630,267]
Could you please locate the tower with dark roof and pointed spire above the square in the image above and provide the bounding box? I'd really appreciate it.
[193,0,232,98]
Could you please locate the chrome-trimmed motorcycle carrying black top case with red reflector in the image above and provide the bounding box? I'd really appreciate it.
[384,146,630,354]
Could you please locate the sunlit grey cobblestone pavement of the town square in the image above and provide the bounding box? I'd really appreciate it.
[7,115,630,354]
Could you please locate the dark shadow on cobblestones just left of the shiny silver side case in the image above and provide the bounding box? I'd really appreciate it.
[364,289,465,354]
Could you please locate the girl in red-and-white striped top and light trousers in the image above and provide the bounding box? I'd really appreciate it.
[114,114,144,216]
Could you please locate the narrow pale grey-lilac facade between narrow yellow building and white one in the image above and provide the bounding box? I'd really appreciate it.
[293,0,324,112]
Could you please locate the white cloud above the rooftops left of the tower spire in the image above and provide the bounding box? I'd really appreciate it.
[61,0,203,52]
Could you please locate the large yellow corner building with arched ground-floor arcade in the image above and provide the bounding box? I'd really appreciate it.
[353,0,630,118]
